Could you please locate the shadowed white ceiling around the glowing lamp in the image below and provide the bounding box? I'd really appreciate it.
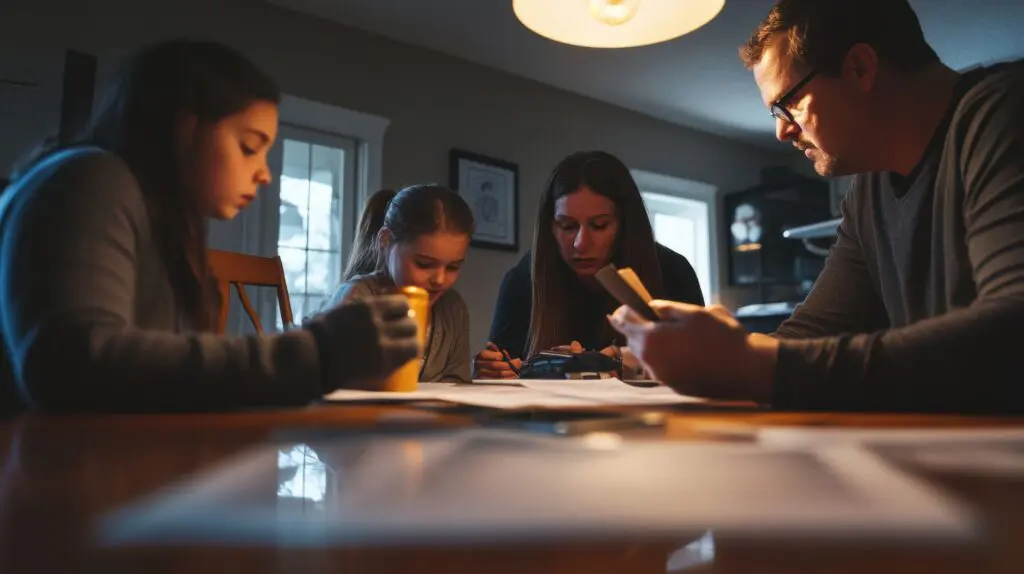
[265,0,1024,146]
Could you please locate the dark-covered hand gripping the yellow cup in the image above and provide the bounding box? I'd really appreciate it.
[309,295,421,392]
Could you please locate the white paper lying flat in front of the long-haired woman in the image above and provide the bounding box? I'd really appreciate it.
[324,379,702,408]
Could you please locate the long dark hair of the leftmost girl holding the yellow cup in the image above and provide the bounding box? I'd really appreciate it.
[16,40,281,330]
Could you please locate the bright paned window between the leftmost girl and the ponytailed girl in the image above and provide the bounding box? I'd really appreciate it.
[275,128,355,329]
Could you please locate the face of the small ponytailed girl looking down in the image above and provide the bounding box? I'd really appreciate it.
[380,228,469,305]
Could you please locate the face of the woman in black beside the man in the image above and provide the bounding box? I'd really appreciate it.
[552,185,618,277]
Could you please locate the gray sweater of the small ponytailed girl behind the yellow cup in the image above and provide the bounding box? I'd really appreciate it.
[326,273,472,383]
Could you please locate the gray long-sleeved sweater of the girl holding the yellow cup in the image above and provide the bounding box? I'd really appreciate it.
[0,148,379,412]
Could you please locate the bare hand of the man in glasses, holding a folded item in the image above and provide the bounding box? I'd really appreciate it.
[608,301,778,402]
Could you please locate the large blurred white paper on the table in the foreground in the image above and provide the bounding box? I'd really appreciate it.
[102,429,975,545]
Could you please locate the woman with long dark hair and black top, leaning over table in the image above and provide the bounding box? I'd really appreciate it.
[475,151,703,379]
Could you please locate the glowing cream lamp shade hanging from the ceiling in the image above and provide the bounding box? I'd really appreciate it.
[512,0,725,48]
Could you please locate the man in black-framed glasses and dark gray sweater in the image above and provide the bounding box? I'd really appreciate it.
[612,0,1024,412]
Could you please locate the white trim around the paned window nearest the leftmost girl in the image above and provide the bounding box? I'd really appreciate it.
[278,94,391,211]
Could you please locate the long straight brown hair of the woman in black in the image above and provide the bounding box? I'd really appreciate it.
[526,151,663,356]
